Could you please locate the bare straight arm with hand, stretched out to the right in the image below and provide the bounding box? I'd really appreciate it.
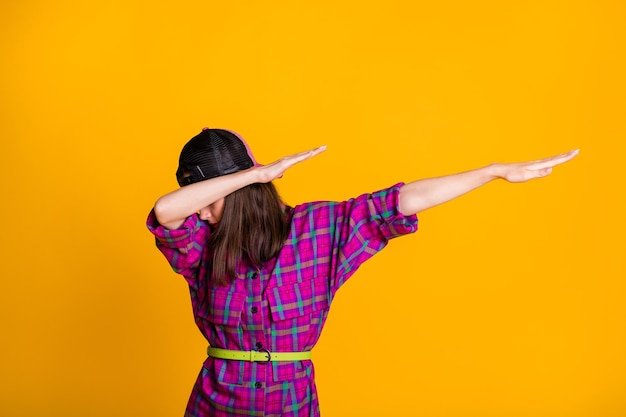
[400,150,578,216]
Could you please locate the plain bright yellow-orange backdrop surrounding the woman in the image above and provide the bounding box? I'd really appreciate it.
[0,0,626,417]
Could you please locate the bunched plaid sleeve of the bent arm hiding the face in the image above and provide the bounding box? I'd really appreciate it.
[146,209,210,281]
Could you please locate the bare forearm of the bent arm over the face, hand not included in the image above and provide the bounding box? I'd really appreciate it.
[154,169,258,229]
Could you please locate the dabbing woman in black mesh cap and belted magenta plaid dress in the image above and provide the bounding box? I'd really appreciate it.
[147,129,578,417]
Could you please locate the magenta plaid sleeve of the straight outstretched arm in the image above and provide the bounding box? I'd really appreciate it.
[331,183,417,292]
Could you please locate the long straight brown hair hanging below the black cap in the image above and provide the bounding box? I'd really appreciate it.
[209,182,289,285]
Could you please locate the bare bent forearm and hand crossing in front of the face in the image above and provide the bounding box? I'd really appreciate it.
[154,146,326,229]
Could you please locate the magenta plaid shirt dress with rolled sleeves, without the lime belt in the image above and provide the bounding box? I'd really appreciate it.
[147,184,417,417]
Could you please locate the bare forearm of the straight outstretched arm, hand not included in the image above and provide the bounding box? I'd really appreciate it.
[399,164,501,216]
